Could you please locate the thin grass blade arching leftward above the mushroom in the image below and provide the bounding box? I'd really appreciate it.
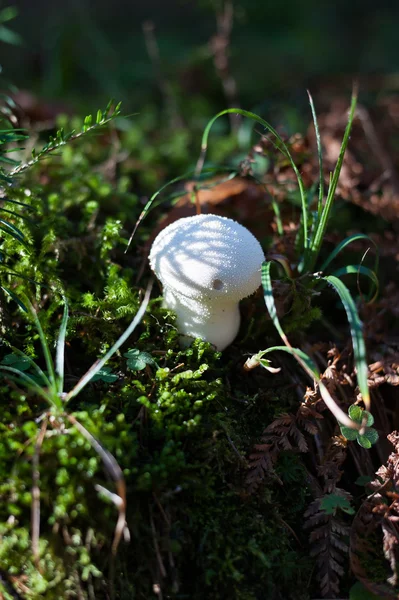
[195,108,309,248]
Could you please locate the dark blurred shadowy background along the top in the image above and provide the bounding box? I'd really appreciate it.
[1,0,399,112]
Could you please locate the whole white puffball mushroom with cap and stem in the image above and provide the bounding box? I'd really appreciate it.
[149,214,265,350]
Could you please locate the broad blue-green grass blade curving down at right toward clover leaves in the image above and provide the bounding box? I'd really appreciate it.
[323,275,370,410]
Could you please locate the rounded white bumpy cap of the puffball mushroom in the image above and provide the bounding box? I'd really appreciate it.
[149,214,265,303]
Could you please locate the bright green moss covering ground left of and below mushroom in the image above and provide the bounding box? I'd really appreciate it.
[0,110,312,600]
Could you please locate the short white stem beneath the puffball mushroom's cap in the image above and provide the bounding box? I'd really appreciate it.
[163,286,241,350]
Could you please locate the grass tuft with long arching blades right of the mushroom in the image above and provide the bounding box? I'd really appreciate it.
[185,88,378,430]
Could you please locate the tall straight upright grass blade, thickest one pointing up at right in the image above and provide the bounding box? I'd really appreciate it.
[304,86,357,272]
